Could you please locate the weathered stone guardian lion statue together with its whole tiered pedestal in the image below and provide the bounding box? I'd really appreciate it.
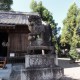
[22,15,63,80]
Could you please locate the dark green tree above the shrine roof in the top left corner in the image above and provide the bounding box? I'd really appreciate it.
[0,0,13,11]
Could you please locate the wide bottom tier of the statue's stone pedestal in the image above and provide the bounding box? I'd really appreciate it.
[21,66,63,80]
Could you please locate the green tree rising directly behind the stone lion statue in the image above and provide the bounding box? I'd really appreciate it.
[30,0,58,41]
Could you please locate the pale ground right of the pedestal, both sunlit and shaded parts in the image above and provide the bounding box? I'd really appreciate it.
[58,58,80,80]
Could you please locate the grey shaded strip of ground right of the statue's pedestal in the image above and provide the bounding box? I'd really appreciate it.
[58,58,80,68]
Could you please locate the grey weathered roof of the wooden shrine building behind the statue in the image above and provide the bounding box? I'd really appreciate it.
[0,11,39,25]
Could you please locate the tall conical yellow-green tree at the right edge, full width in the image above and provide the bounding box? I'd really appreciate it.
[61,3,80,60]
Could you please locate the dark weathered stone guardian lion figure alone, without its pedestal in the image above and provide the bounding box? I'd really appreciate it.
[28,16,52,46]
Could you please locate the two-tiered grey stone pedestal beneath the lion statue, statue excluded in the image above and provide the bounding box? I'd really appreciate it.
[21,54,64,80]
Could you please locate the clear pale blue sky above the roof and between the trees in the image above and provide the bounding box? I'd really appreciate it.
[12,0,80,32]
